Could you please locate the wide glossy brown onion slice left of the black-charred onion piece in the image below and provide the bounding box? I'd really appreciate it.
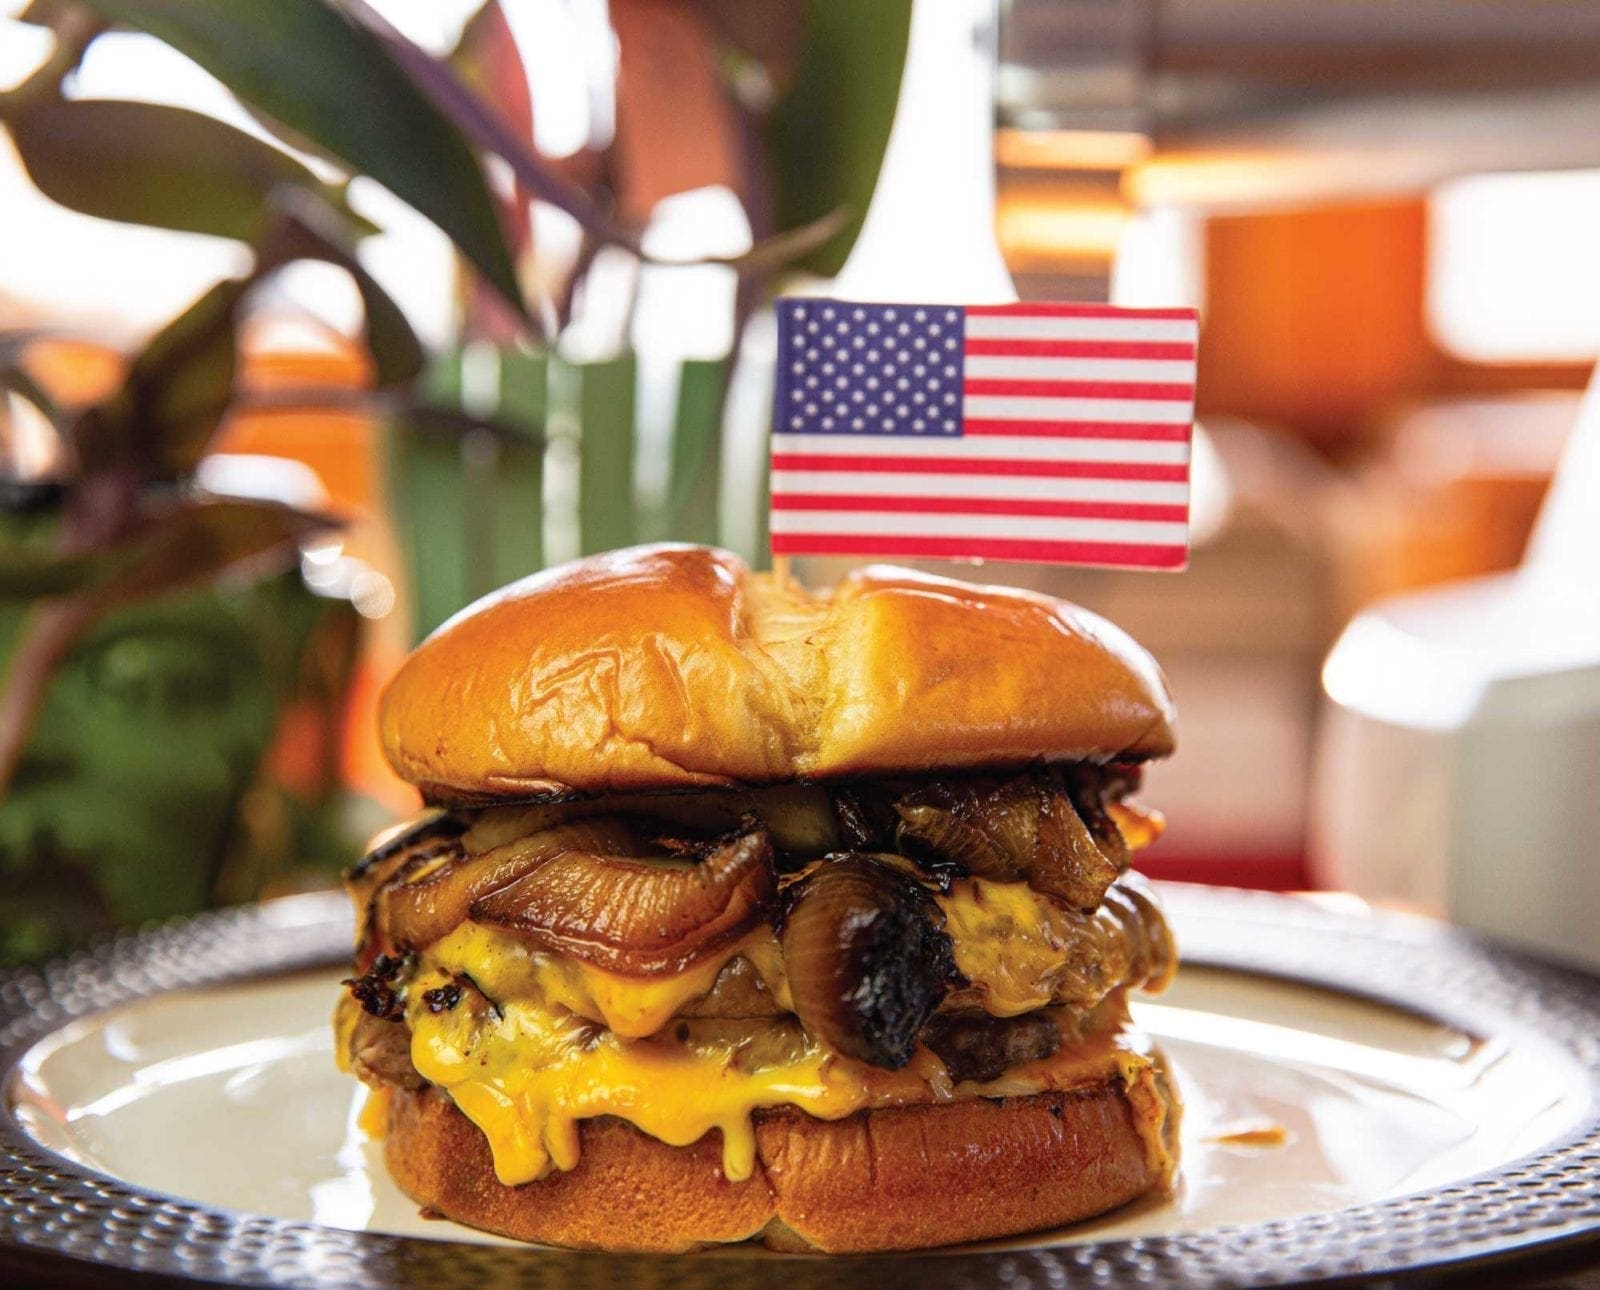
[470,831,778,976]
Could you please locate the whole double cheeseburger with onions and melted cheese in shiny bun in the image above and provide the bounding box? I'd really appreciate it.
[338,546,1178,1250]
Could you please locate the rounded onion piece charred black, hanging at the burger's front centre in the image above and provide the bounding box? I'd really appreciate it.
[782,855,955,1071]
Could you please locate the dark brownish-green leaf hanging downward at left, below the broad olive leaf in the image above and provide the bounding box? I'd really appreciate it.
[74,278,244,479]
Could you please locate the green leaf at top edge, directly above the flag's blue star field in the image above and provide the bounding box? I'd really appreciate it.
[766,0,912,275]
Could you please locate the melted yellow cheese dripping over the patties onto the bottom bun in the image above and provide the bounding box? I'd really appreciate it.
[396,879,1177,1184]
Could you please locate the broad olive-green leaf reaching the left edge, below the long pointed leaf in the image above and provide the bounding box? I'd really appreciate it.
[10,98,376,242]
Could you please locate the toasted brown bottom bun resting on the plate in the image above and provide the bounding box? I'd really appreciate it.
[386,1069,1176,1253]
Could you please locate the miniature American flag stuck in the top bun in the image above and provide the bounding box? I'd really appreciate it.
[771,299,1198,570]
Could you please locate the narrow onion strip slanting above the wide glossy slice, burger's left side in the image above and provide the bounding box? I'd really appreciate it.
[381,816,635,949]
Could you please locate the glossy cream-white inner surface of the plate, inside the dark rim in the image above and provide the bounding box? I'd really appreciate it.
[11,967,1589,1248]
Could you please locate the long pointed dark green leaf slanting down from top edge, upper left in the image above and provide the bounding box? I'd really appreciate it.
[60,0,523,312]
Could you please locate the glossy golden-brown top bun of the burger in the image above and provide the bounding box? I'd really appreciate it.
[379,546,1173,803]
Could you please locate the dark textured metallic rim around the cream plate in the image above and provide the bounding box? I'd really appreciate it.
[0,883,1600,1288]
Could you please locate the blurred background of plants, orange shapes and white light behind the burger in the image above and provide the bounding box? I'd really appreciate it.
[0,0,1600,960]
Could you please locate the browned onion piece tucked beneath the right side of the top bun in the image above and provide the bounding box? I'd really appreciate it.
[894,776,1128,911]
